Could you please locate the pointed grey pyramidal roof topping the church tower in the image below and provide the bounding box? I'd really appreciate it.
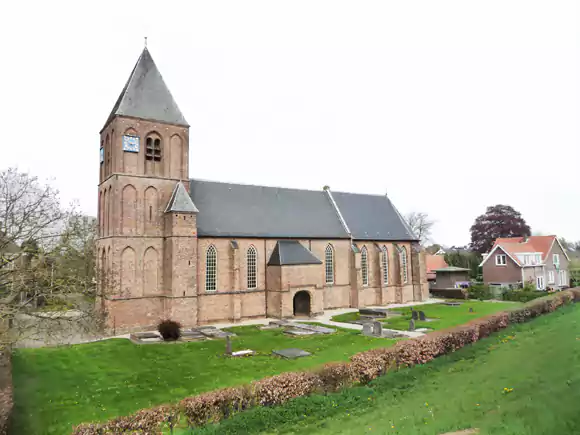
[105,47,189,127]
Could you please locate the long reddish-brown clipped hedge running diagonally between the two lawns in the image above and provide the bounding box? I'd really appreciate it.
[73,289,580,435]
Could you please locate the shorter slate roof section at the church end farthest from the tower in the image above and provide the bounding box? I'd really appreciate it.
[332,192,417,241]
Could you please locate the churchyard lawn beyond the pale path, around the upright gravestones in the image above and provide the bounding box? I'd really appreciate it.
[332,301,521,331]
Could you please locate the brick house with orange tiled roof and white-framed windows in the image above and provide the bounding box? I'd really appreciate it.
[481,236,569,290]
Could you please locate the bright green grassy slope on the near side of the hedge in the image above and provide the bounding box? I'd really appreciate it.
[193,304,580,435]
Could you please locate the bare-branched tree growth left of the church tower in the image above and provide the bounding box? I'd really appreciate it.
[0,169,101,346]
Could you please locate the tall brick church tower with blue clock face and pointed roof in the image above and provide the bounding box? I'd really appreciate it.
[97,48,197,332]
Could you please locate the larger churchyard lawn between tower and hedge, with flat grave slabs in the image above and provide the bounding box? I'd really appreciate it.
[12,326,395,435]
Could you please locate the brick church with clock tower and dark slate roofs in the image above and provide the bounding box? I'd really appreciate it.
[97,48,428,332]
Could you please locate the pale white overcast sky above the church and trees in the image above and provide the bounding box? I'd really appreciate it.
[0,0,580,245]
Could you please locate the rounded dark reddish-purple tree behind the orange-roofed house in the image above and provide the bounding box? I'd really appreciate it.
[471,204,531,254]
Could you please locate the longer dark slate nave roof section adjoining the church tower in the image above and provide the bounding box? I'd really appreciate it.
[190,180,349,239]
